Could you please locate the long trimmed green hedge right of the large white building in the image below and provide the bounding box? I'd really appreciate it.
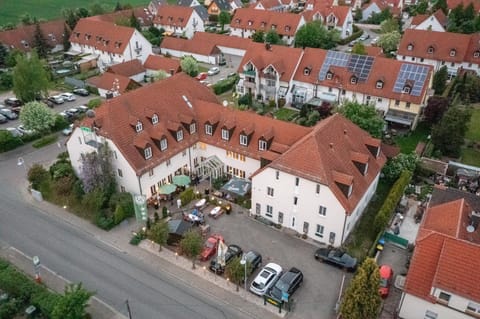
[374,170,412,232]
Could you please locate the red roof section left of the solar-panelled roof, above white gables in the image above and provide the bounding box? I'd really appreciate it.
[238,42,303,82]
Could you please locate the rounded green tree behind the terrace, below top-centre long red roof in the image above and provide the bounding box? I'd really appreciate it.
[295,21,340,50]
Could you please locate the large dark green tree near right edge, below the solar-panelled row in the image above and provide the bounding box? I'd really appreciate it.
[432,106,472,157]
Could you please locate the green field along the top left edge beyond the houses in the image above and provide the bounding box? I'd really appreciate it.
[0,0,149,25]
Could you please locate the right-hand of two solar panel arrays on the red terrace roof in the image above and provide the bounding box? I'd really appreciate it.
[393,63,428,96]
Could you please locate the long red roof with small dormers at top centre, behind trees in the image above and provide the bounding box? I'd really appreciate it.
[230,8,302,36]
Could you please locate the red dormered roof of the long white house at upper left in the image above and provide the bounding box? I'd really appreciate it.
[70,18,135,54]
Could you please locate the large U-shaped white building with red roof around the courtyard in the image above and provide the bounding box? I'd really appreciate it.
[67,73,385,246]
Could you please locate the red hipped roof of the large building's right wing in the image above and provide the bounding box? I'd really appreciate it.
[269,114,386,214]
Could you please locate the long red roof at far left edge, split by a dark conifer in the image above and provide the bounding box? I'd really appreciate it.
[0,20,70,52]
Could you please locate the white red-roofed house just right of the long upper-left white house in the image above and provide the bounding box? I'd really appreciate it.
[153,6,205,39]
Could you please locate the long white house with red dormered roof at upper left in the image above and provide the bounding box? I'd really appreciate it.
[70,18,152,70]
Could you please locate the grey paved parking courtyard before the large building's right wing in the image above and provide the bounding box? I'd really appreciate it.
[193,206,351,319]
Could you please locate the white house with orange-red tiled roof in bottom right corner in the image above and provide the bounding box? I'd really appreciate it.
[399,187,480,319]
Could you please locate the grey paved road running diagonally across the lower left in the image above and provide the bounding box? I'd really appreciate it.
[0,145,274,319]
